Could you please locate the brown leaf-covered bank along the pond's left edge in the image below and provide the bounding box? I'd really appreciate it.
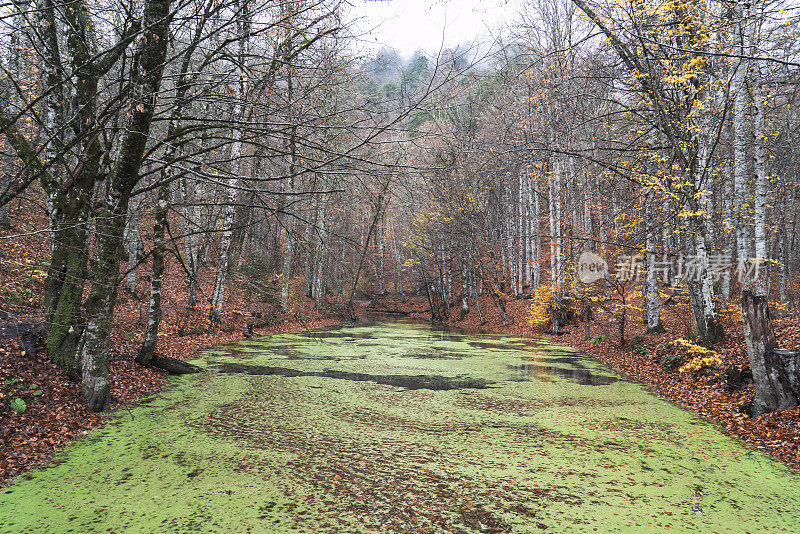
[0,262,341,487]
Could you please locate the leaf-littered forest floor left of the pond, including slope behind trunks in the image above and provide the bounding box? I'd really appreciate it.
[0,220,340,486]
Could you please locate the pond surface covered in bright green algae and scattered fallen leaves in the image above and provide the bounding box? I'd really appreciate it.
[0,322,800,532]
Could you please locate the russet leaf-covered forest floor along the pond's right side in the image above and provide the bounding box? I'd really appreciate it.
[372,294,800,469]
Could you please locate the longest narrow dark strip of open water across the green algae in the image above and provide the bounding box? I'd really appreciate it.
[209,362,494,391]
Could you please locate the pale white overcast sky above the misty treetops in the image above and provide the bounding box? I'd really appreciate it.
[351,0,522,57]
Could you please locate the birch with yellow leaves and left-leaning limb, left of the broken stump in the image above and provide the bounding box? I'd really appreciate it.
[573,0,724,345]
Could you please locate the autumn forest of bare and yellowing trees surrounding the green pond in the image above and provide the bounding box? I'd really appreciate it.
[0,0,800,532]
